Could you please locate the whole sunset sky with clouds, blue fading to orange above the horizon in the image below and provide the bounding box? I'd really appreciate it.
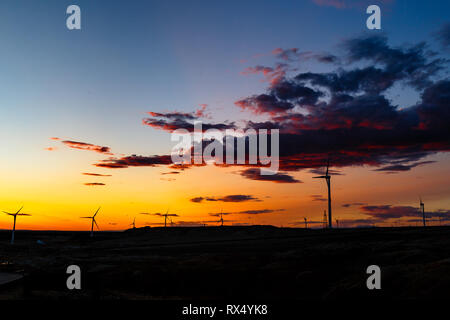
[0,0,450,230]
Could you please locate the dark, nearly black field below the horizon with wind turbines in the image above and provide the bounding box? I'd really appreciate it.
[0,226,450,300]
